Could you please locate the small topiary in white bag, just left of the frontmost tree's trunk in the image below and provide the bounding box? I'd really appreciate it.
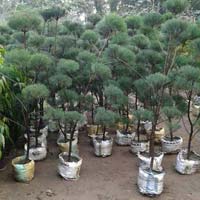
[130,108,152,153]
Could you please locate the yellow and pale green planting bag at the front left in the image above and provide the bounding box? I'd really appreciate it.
[12,156,35,182]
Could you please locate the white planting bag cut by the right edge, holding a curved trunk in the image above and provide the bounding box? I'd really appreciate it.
[175,149,200,174]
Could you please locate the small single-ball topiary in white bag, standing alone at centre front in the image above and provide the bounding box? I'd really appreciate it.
[93,107,115,157]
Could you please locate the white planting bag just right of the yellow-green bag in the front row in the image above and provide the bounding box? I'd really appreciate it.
[58,152,82,180]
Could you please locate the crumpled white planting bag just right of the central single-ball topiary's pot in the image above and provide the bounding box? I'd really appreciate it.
[115,130,135,146]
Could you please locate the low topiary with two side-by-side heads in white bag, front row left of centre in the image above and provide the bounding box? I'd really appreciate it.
[46,108,84,180]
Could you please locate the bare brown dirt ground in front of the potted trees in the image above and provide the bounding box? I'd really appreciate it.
[0,125,200,200]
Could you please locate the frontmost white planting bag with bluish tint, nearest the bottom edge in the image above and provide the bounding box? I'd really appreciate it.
[137,167,165,196]
